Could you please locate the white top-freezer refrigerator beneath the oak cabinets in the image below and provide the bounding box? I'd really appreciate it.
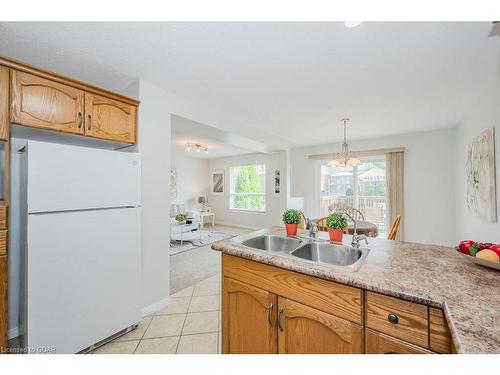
[20,141,142,353]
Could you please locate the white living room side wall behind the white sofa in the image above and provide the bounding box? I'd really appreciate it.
[172,147,209,210]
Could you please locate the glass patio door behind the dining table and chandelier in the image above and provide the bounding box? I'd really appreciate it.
[320,155,387,238]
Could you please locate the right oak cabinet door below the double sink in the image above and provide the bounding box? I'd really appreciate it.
[278,297,363,354]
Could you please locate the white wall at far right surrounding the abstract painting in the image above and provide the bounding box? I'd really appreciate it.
[456,74,500,242]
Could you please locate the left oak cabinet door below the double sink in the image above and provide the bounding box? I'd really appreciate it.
[222,277,278,354]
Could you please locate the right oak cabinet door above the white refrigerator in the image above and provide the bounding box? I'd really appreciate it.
[85,93,137,143]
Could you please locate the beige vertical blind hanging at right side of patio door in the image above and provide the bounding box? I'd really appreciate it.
[386,152,405,241]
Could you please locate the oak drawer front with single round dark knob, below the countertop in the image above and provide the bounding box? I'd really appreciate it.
[366,292,429,348]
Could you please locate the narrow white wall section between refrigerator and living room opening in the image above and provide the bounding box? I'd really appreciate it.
[138,81,171,314]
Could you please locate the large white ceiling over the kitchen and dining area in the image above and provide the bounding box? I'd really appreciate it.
[0,22,500,146]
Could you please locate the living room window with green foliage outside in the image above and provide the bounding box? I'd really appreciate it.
[229,164,266,212]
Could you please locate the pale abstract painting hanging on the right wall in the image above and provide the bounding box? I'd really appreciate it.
[466,128,497,222]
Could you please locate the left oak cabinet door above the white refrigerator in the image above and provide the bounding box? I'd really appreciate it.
[11,70,84,134]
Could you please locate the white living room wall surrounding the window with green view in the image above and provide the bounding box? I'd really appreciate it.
[207,151,287,228]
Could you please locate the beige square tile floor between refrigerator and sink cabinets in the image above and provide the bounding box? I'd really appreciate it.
[94,275,220,354]
